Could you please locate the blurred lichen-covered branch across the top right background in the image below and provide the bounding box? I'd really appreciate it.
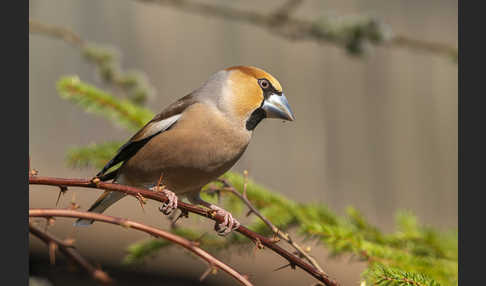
[137,0,457,59]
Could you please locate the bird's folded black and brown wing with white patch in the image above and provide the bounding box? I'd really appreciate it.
[96,94,196,181]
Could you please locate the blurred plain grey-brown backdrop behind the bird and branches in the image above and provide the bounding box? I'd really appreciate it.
[29,0,458,285]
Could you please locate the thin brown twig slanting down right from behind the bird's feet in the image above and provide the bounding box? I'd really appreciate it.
[208,179,324,273]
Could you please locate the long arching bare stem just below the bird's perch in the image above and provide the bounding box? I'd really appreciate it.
[29,209,253,286]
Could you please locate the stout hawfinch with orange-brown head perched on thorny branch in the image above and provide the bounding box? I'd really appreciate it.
[75,65,295,236]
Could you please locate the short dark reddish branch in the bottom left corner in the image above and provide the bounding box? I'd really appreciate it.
[29,222,113,284]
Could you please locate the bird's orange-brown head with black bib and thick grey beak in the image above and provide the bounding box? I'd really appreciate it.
[207,66,295,130]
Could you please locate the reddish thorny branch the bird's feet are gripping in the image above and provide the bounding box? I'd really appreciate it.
[29,176,339,286]
